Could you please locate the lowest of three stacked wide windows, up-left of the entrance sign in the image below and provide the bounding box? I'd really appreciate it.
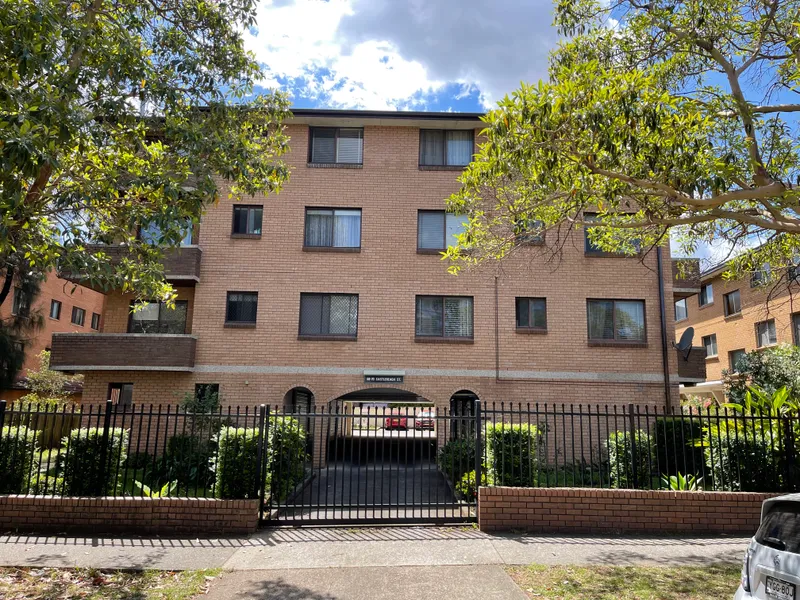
[300,294,358,338]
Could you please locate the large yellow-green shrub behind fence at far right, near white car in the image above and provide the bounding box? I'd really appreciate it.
[703,421,783,492]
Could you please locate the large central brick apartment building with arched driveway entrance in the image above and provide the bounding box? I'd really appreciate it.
[52,110,698,407]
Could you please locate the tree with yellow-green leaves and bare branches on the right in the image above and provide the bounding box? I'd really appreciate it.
[447,0,800,283]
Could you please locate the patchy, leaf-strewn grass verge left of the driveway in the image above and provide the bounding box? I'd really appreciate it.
[0,568,219,600]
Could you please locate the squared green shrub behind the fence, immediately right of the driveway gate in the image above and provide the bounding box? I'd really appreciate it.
[486,423,540,487]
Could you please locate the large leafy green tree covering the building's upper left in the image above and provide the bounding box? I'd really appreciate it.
[0,0,288,304]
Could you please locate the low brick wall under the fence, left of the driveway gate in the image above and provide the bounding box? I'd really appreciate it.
[0,496,258,536]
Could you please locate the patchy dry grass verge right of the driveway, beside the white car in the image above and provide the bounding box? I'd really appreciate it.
[506,565,742,600]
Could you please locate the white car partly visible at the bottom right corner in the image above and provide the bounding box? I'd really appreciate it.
[734,494,800,600]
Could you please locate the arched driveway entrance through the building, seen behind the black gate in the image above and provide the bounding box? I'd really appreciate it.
[270,387,475,524]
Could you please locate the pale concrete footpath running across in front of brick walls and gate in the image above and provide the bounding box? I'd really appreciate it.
[0,527,748,571]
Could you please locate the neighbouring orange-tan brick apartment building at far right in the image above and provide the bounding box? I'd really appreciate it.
[675,264,800,400]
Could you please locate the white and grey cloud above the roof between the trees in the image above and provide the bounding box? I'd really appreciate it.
[245,0,557,109]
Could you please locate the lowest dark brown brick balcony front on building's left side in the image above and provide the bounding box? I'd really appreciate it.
[50,333,197,371]
